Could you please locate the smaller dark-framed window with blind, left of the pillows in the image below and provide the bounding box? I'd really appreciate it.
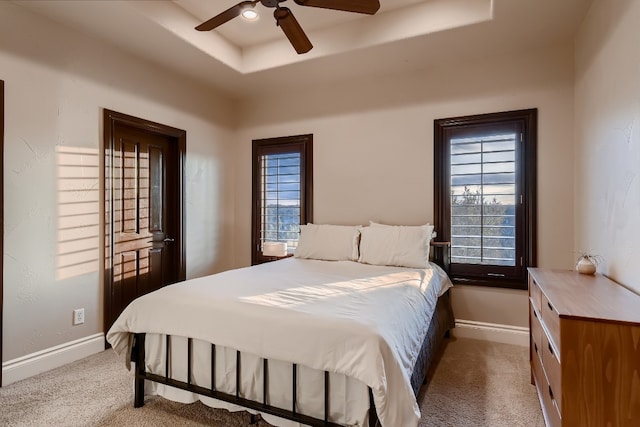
[251,135,313,264]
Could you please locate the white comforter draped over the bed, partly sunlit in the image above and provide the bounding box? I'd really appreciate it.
[107,258,451,427]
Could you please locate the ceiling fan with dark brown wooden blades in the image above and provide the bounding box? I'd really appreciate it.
[196,0,380,54]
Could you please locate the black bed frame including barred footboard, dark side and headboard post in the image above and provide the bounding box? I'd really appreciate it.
[131,243,455,427]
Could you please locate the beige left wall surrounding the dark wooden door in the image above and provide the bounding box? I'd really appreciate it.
[0,2,233,360]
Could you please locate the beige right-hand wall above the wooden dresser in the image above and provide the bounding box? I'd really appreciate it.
[575,0,640,293]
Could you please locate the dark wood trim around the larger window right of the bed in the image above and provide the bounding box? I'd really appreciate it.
[434,109,537,289]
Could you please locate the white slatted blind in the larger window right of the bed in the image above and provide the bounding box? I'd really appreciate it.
[450,133,519,266]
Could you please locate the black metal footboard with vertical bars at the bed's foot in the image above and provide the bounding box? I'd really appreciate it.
[131,333,364,427]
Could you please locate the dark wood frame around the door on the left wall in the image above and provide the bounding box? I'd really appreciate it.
[102,108,187,347]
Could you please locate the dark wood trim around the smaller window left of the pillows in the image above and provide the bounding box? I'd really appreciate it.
[251,134,313,265]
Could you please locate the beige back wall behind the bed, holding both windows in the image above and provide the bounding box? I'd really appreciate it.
[235,45,573,326]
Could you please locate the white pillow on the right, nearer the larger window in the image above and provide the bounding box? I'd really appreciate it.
[358,222,433,268]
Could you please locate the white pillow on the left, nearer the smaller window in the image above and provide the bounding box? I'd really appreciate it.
[294,224,361,261]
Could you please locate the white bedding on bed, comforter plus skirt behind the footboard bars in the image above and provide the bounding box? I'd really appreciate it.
[107,258,451,426]
